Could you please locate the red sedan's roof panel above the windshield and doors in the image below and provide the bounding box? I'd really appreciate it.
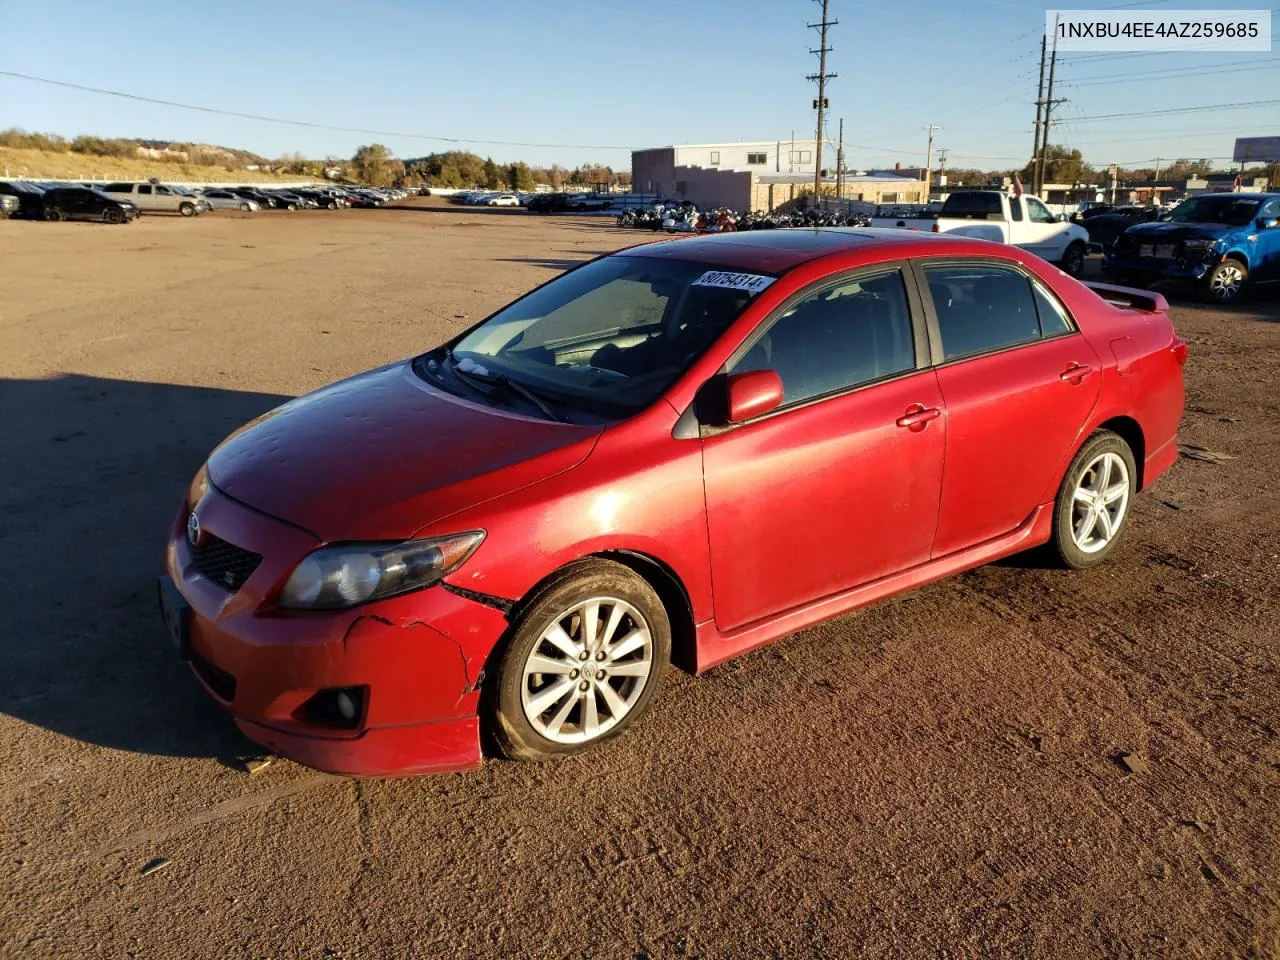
[618,227,998,274]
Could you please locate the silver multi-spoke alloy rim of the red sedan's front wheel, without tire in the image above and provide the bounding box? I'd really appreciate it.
[520,596,654,744]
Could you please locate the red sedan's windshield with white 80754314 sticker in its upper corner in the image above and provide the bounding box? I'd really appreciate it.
[440,256,774,412]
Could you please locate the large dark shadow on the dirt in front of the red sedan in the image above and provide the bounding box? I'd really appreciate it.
[0,374,288,762]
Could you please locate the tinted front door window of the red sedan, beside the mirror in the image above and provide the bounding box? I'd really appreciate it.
[728,270,915,403]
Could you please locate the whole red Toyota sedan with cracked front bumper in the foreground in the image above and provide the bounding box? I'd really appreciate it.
[160,229,1187,776]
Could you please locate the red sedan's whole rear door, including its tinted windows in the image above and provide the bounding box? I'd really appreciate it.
[915,259,1102,557]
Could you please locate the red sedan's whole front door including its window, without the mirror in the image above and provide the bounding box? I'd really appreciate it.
[703,268,946,630]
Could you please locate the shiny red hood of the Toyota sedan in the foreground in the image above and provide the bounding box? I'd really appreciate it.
[209,361,602,541]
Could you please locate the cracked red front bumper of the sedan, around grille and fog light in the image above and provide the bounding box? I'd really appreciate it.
[165,488,507,776]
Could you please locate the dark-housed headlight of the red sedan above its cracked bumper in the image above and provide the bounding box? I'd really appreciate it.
[280,530,484,609]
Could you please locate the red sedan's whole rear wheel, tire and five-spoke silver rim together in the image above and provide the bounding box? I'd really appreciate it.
[1050,430,1138,570]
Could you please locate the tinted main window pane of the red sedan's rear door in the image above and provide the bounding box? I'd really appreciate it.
[924,264,1041,360]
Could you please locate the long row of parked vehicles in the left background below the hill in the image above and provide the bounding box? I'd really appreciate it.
[0,180,410,224]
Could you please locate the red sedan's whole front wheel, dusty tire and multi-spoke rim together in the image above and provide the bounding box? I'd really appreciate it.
[481,559,671,760]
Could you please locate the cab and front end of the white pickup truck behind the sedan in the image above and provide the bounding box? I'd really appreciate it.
[931,189,1089,276]
